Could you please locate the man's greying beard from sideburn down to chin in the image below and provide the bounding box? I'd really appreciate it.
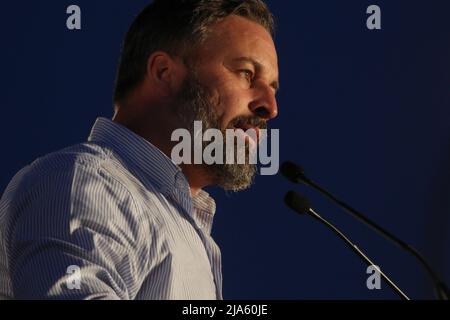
[174,72,257,192]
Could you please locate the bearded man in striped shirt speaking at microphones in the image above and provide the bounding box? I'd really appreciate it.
[0,0,278,299]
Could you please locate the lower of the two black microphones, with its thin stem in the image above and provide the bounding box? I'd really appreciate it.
[284,191,410,300]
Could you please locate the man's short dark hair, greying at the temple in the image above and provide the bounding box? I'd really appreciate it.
[114,0,274,103]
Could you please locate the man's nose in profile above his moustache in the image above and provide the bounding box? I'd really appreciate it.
[250,83,278,121]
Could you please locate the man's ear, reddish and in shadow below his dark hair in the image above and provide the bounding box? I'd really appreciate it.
[147,51,186,96]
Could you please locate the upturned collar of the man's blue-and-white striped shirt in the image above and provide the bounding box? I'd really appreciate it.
[88,118,216,234]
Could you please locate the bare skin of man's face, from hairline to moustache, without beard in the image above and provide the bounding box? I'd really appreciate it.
[195,16,278,129]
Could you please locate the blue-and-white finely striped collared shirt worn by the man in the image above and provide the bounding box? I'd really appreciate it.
[0,118,222,300]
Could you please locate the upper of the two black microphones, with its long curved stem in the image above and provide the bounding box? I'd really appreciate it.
[280,161,450,300]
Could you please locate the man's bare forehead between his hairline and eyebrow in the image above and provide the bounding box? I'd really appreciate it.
[199,15,278,77]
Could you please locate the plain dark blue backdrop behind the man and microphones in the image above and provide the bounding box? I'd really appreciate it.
[0,0,450,299]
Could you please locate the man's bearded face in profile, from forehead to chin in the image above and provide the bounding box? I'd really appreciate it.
[176,16,278,191]
